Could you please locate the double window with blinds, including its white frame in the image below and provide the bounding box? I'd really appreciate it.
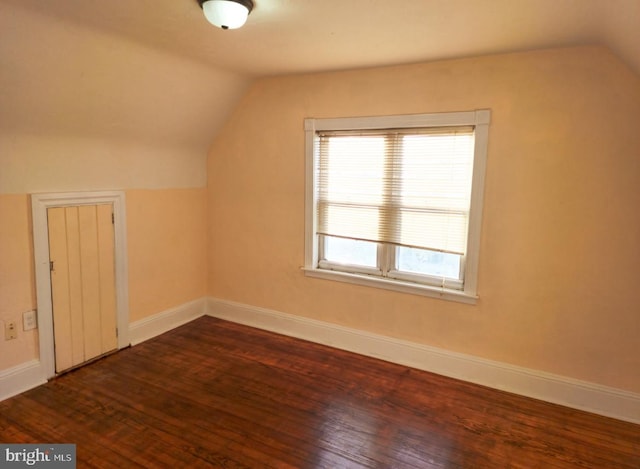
[305,110,490,303]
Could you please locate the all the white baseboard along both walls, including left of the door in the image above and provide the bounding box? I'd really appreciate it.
[6,298,640,424]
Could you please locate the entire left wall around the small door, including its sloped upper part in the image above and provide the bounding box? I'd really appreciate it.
[0,1,222,372]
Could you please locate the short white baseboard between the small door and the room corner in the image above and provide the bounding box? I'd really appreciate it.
[129,298,207,345]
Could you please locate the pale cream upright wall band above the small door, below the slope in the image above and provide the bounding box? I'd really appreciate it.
[0,137,207,194]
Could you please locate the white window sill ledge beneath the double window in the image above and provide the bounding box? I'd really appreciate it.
[302,267,478,305]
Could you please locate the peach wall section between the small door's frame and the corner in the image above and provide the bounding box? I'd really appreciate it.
[127,188,207,321]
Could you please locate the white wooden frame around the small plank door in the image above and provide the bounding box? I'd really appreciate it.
[31,191,130,379]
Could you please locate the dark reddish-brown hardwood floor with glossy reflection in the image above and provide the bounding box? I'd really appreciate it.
[0,317,640,469]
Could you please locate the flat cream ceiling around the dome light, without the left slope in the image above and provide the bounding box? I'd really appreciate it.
[0,0,640,76]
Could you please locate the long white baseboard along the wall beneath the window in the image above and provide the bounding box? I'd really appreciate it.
[206,298,640,423]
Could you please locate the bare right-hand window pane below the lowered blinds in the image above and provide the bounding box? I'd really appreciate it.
[396,247,462,279]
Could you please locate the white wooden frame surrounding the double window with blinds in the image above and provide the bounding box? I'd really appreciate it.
[303,109,491,304]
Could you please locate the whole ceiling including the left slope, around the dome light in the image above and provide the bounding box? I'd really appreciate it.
[0,0,640,158]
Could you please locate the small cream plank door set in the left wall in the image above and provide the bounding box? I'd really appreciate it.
[47,204,118,373]
